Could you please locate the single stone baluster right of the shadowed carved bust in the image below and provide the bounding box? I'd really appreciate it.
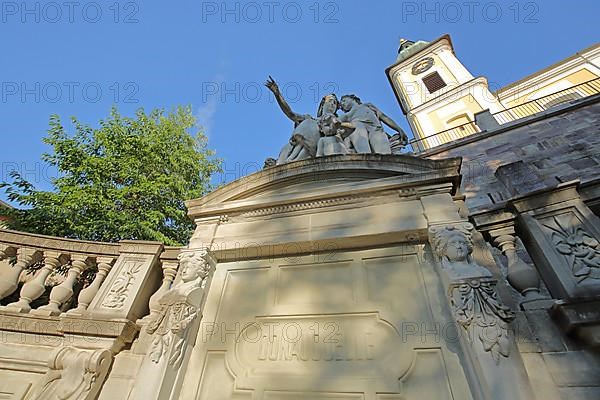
[490,227,542,303]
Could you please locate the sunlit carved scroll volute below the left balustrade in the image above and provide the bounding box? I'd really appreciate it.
[27,347,112,400]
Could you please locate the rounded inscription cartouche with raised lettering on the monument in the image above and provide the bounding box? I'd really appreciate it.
[229,313,412,391]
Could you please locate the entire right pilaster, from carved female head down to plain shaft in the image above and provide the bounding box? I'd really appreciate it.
[429,221,533,400]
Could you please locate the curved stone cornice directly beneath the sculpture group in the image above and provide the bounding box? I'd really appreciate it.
[186,154,461,220]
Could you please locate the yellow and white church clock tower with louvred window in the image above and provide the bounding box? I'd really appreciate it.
[386,35,504,150]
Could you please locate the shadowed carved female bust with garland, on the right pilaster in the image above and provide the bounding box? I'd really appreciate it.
[430,223,515,364]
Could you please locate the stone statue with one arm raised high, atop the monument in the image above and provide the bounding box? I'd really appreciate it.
[265,76,339,165]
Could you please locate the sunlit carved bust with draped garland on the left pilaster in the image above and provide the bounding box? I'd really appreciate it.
[146,250,210,368]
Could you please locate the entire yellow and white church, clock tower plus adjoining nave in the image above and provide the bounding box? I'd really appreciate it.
[386,35,600,152]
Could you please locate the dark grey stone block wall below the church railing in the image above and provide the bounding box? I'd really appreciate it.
[420,96,600,211]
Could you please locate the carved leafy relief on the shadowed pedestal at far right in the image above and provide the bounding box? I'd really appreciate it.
[542,214,600,282]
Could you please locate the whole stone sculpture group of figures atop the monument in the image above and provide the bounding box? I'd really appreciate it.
[265,77,408,166]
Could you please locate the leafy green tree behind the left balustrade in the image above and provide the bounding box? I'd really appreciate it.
[0,107,221,245]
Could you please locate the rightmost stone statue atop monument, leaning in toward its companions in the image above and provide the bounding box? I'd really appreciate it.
[339,94,408,154]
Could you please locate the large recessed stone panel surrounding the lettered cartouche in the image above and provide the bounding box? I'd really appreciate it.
[180,246,472,400]
